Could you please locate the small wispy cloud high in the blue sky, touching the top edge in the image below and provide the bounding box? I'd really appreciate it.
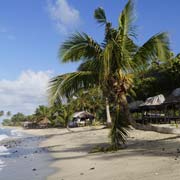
[48,0,80,34]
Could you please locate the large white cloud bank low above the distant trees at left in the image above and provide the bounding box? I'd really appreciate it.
[0,70,52,114]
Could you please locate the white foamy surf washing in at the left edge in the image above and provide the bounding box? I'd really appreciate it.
[0,127,22,171]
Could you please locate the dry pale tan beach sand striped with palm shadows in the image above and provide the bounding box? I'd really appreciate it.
[20,127,180,180]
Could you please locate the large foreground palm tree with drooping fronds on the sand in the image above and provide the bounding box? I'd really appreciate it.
[50,0,169,148]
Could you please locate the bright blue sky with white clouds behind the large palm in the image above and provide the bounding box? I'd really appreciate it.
[0,0,180,117]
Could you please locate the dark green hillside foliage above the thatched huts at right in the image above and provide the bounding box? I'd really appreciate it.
[134,55,180,100]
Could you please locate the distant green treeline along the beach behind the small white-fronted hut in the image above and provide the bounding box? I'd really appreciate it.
[2,88,106,127]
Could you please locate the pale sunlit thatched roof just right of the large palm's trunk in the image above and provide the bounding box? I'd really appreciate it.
[140,94,165,107]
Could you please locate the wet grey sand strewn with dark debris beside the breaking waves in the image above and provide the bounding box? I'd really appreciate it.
[0,127,54,180]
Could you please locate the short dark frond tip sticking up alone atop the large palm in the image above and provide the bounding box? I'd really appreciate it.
[94,7,107,25]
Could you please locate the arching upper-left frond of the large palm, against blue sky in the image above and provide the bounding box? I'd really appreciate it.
[59,32,102,62]
